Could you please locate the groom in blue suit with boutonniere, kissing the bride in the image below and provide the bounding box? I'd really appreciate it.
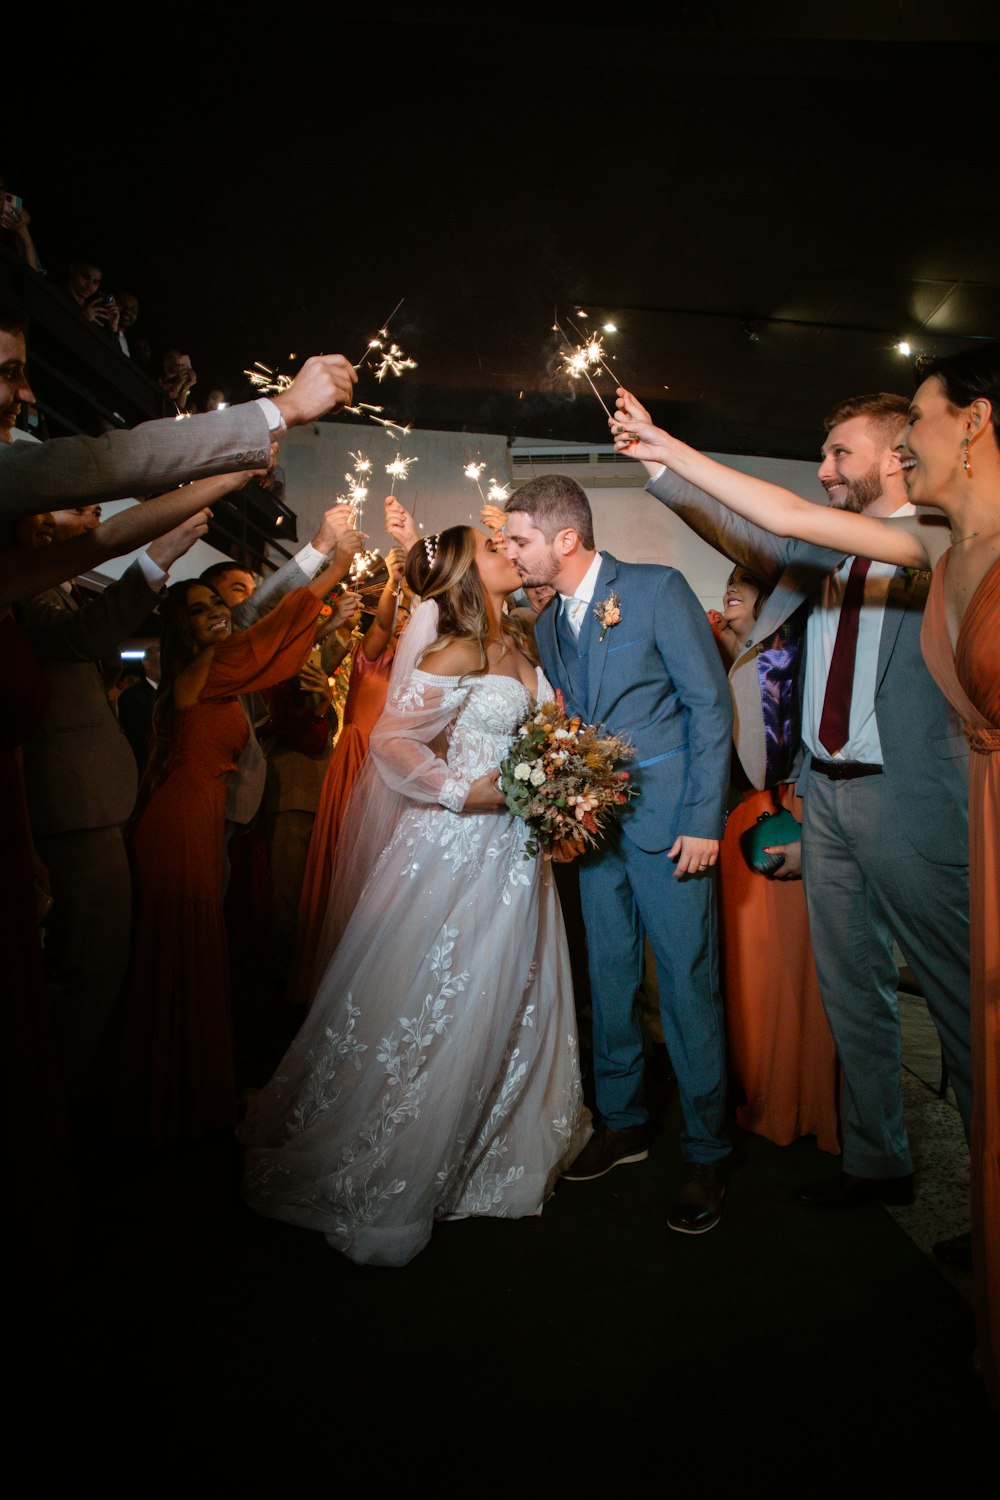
[505,474,733,1235]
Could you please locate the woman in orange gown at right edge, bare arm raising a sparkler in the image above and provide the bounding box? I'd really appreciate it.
[613,344,1000,1415]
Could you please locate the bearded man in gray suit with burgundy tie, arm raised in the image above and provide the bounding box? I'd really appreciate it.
[624,393,972,1208]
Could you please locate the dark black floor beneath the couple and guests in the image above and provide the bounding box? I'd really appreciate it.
[23,1002,997,1494]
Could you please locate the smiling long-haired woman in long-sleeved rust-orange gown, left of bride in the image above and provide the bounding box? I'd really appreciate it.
[111,582,322,1146]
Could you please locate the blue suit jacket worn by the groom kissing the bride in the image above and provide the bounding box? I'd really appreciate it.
[535,552,733,854]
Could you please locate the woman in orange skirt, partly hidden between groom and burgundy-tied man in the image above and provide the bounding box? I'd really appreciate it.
[712,567,840,1152]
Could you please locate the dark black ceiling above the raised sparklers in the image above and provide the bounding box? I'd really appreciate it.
[9,0,1000,458]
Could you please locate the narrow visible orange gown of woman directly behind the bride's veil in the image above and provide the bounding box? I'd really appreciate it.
[288,548,408,1005]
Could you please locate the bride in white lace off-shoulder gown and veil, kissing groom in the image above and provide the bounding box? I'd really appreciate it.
[240,527,589,1266]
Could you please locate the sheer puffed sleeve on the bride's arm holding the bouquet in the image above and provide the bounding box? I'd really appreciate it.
[369,671,472,813]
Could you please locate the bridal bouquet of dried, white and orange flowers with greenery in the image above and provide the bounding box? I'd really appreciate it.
[498,693,637,857]
